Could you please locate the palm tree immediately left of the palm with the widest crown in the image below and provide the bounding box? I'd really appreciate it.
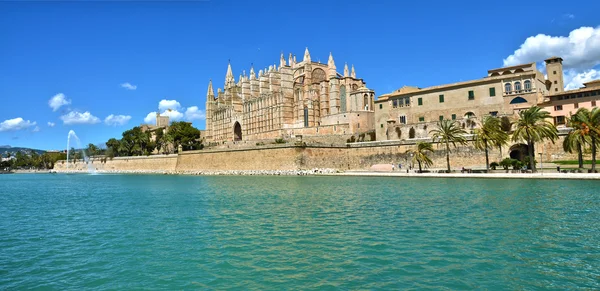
[475,116,508,171]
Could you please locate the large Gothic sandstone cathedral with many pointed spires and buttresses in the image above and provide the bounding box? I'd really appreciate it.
[205,48,375,142]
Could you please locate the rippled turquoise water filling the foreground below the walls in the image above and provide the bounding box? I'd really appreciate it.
[0,174,600,290]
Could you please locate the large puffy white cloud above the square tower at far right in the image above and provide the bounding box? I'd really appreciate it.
[504,27,600,70]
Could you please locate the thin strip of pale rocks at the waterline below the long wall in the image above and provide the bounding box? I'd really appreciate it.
[54,168,339,176]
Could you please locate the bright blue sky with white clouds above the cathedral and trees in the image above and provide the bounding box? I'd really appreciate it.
[0,1,600,149]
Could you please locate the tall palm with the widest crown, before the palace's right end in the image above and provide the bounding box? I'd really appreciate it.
[512,106,558,172]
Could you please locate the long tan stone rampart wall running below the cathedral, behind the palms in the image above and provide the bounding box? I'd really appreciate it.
[55,137,589,172]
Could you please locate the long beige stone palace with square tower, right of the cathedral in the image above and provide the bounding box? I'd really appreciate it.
[375,57,564,140]
